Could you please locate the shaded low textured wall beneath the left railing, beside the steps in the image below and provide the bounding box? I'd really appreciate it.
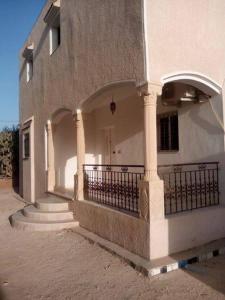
[75,201,149,259]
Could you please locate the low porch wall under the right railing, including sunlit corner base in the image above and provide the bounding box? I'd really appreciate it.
[150,205,225,259]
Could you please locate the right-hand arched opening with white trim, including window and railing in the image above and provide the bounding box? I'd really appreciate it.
[157,72,224,214]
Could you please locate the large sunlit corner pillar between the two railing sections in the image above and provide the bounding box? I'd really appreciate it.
[139,83,168,259]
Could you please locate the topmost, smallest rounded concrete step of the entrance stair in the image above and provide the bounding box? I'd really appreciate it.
[34,196,69,212]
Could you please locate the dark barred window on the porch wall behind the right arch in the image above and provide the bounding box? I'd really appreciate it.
[158,112,179,151]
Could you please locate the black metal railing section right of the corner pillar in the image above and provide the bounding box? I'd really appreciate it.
[158,162,219,215]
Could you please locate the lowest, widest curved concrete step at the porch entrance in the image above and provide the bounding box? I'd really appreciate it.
[10,211,79,231]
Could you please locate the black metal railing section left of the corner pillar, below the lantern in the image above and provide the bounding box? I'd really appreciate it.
[83,165,144,213]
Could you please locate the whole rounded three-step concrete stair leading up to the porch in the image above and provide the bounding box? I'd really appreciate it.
[10,196,79,231]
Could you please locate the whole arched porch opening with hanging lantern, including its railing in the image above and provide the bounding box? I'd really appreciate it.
[80,82,144,214]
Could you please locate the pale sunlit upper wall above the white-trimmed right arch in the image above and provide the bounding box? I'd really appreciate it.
[145,0,225,85]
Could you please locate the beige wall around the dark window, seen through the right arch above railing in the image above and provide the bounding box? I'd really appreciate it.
[158,99,224,165]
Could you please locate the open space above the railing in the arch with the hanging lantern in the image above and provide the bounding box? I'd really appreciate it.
[81,82,143,165]
